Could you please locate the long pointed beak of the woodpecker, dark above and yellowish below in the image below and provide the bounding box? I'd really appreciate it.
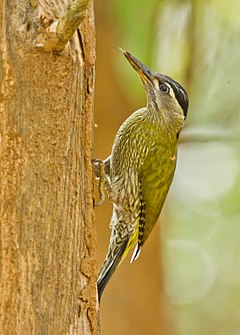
[121,49,154,91]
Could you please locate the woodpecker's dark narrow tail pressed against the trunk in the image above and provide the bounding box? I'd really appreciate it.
[97,239,129,303]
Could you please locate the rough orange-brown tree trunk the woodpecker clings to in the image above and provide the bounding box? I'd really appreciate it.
[0,0,98,335]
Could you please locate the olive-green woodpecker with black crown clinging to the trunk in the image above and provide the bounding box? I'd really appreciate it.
[94,51,188,301]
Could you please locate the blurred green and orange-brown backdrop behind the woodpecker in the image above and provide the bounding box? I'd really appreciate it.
[94,0,240,335]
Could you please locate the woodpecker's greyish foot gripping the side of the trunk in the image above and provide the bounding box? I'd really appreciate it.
[92,159,110,206]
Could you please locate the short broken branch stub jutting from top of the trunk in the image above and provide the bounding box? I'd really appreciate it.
[36,0,89,52]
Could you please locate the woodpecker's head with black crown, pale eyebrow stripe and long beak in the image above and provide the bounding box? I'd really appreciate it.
[123,51,188,130]
